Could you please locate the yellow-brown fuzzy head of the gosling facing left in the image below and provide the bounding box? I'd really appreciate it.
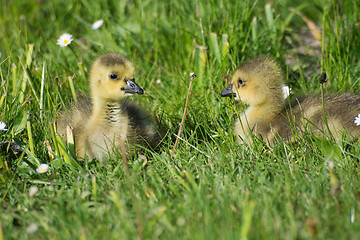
[221,57,284,106]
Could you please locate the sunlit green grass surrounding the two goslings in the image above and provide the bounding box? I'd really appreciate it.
[0,0,360,240]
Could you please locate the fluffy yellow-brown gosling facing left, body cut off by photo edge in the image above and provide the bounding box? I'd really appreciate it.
[221,57,360,144]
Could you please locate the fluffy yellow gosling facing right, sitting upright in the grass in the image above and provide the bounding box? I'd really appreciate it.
[58,54,163,161]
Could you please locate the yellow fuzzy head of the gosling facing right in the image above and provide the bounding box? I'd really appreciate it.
[90,54,144,101]
